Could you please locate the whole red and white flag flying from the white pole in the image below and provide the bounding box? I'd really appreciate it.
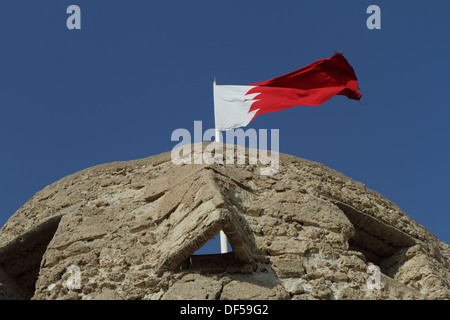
[214,53,361,130]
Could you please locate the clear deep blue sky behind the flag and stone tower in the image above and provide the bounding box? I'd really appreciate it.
[0,0,450,251]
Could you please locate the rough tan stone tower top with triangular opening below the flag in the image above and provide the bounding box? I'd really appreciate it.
[0,143,450,299]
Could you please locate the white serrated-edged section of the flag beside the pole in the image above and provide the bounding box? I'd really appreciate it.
[214,85,259,131]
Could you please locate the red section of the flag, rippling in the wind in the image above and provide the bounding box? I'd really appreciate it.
[247,53,362,118]
